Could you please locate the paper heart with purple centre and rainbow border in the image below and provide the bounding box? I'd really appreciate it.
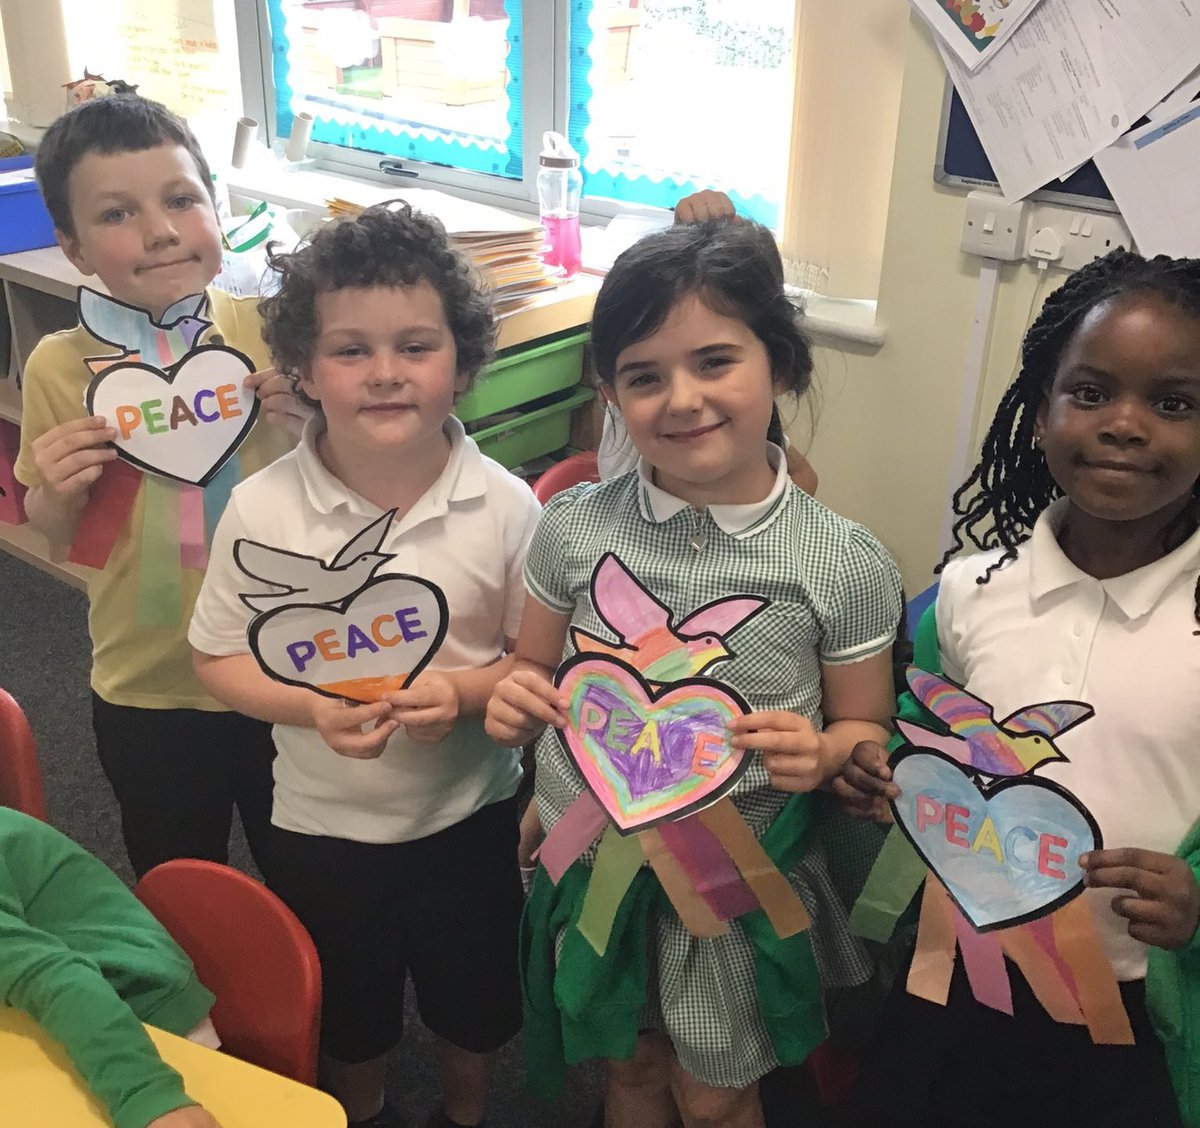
[554,654,750,834]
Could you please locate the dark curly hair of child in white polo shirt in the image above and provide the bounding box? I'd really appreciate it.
[258,202,496,402]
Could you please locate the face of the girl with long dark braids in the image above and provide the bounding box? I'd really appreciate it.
[1038,293,1200,522]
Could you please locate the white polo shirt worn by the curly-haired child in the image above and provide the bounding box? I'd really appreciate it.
[187,416,539,842]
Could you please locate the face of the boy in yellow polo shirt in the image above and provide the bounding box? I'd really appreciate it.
[58,145,221,318]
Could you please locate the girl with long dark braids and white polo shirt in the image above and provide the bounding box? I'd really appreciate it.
[835,251,1200,1128]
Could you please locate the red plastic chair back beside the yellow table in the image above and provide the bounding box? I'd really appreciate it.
[133,858,320,1085]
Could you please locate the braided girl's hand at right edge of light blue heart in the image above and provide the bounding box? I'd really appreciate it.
[1079,847,1200,949]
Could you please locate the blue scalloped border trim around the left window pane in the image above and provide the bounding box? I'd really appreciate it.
[269,0,524,180]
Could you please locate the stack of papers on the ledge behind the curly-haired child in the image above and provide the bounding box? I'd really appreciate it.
[326,185,562,318]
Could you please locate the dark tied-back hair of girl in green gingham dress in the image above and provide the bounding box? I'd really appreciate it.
[592,220,812,397]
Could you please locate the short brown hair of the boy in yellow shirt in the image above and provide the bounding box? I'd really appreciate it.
[34,94,214,236]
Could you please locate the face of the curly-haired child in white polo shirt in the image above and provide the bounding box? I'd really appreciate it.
[301,281,467,461]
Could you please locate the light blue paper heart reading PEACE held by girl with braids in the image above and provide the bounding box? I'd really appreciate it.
[892,749,1103,932]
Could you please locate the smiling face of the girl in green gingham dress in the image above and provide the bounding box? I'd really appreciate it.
[604,294,775,505]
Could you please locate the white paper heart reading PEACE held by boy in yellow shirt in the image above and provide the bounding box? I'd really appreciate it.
[86,344,258,486]
